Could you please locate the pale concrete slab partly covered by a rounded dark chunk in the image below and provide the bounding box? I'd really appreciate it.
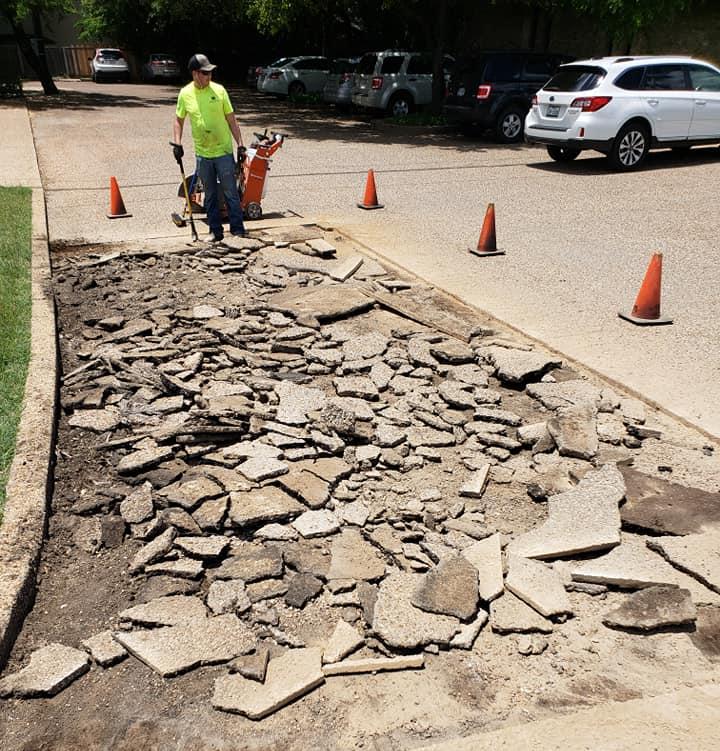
[372,572,461,649]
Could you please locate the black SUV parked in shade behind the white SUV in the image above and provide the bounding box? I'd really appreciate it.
[443,52,573,143]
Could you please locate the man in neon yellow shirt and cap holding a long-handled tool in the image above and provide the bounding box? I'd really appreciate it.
[173,54,245,243]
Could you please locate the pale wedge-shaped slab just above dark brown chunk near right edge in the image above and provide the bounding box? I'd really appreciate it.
[570,534,720,605]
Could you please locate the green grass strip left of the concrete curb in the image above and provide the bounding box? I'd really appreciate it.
[0,187,32,520]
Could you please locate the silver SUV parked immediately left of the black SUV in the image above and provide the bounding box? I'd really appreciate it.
[352,50,453,116]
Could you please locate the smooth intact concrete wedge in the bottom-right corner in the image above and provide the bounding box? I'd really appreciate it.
[418,684,720,751]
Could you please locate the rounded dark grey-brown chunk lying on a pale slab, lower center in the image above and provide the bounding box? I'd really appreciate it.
[411,554,479,621]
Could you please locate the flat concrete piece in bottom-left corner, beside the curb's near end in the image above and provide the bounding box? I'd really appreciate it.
[0,644,90,699]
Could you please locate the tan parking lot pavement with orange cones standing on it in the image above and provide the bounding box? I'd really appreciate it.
[27,81,720,437]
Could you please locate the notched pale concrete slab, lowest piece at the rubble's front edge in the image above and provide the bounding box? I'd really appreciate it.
[212,648,325,720]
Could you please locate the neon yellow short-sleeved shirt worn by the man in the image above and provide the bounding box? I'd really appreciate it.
[175,81,233,158]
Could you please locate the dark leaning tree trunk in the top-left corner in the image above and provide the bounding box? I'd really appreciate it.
[0,0,75,95]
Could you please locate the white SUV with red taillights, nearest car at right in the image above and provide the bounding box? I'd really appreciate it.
[525,56,720,170]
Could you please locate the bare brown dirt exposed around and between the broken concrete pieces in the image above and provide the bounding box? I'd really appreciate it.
[0,231,720,751]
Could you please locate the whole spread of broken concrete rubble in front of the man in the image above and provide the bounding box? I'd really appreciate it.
[0,228,720,719]
